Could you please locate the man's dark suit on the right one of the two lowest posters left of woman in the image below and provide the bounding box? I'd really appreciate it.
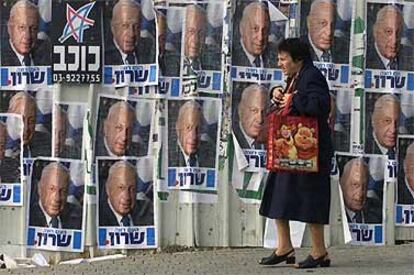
[99,200,154,226]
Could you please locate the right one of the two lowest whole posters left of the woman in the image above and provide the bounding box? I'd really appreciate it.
[96,157,157,249]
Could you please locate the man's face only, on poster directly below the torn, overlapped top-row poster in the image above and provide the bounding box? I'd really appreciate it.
[177,107,201,156]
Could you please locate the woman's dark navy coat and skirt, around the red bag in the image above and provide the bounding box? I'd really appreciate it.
[259,60,333,224]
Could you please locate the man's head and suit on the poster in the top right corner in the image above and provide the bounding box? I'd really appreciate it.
[366,5,414,70]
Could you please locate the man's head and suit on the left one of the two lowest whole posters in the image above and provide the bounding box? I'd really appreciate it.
[29,162,82,230]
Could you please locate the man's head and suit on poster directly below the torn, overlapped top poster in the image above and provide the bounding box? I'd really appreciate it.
[168,101,216,168]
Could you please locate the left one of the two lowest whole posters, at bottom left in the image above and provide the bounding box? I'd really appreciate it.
[27,158,86,252]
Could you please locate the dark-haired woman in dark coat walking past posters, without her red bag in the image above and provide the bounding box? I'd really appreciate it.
[260,38,333,268]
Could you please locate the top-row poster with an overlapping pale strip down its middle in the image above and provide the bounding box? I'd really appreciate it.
[157,0,225,97]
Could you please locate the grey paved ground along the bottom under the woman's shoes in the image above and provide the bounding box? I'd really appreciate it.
[0,243,414,275]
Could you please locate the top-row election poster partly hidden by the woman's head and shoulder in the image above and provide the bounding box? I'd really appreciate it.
[300,0,354,89]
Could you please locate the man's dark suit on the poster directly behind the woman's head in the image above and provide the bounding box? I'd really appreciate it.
[301,35,350,64]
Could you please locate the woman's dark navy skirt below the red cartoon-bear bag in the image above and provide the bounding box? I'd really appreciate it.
[259,169,331,224]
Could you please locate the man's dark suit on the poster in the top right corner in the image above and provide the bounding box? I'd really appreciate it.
[366,43,414,71]
